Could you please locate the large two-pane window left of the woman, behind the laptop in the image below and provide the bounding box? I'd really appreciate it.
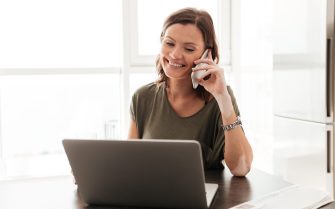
[0,0,122,176]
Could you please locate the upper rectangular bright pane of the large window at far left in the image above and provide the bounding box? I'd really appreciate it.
[0,0,122,68]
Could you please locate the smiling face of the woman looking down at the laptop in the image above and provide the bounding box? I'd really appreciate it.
[160,24,205,79]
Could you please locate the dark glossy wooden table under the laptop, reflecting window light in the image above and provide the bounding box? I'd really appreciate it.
[0,169,335,209]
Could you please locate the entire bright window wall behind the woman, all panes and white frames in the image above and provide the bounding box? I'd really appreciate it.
[0,0,230,178]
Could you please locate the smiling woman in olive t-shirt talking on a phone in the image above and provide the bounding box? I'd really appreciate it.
[128,8,253,176]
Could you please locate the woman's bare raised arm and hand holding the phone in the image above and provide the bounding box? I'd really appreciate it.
[195,50,253,176]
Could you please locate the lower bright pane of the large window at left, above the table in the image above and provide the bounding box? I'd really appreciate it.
[0,74,121,175]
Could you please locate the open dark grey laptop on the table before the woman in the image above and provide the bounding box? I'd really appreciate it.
[63,139,218,209]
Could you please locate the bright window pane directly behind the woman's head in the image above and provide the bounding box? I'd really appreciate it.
[137,0,218,55]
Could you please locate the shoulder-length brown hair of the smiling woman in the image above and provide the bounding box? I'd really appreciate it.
[156,8,219,102]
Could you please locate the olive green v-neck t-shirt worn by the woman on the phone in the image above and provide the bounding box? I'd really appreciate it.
[130,83,239,169]
